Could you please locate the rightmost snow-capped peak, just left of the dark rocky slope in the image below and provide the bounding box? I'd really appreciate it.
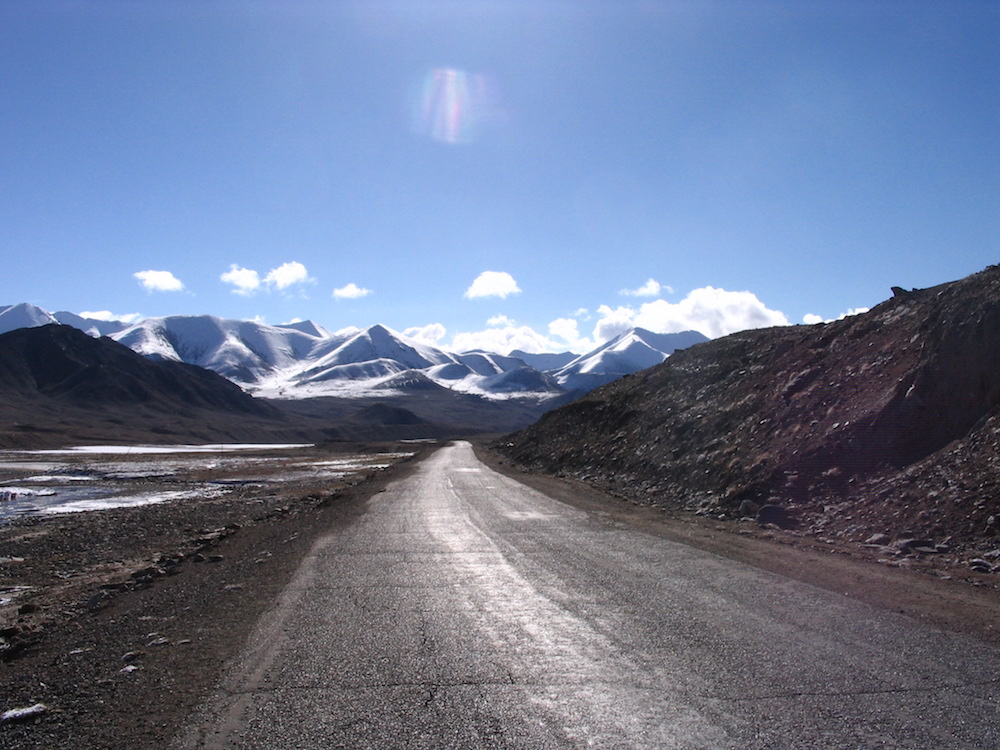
[551,328,708,391]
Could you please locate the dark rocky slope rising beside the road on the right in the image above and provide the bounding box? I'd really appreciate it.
[497,266,1000,556]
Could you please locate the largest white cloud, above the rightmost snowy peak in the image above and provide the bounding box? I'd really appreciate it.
[594,286,788,341]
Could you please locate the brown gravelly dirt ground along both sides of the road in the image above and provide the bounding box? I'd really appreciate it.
[0,447,1000,750]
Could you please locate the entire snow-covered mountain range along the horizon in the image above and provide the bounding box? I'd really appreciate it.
[0,303,707,403]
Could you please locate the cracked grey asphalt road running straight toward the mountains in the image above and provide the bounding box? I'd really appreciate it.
[179,443,1000,750]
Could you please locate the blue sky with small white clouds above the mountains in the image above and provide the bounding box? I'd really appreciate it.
[0,0,1000,350]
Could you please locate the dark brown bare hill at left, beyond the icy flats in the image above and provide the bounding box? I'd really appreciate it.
[0,325,308,448]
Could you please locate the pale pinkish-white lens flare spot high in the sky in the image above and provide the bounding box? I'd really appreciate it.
[414,68,492,143]
